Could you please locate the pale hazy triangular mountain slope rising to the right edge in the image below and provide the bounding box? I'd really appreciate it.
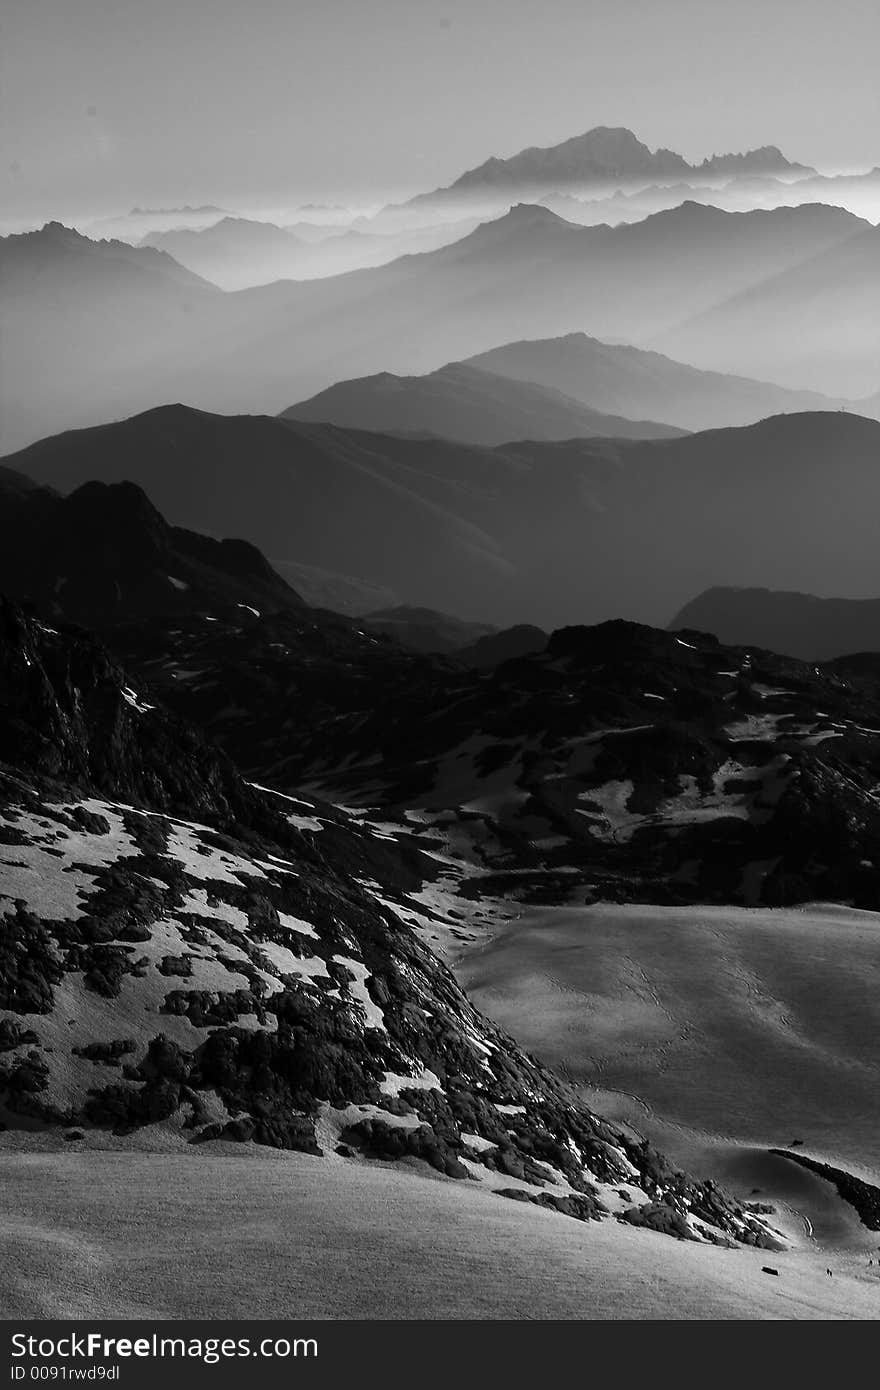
[651,227,880,398]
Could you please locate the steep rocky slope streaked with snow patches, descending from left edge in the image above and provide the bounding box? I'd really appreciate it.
[0,603,774,1245]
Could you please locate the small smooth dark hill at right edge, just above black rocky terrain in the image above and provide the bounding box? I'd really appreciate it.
[670,588,880,662]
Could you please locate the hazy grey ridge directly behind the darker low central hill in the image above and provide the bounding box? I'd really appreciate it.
[466,334,861,430]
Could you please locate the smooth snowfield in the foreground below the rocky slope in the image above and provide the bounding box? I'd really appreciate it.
[0,1151,880,1321]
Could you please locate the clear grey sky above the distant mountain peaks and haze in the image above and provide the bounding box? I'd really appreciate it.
[0,0,880,225]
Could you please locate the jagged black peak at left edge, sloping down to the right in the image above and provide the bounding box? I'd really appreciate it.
[0,470,302,627]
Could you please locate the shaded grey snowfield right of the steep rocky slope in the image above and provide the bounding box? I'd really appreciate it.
[456,900,880,1251]
